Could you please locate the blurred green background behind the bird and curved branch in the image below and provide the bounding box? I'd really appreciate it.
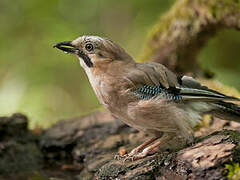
[0,0,240,128]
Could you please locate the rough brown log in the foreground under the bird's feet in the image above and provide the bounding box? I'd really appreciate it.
[0,112,240,180]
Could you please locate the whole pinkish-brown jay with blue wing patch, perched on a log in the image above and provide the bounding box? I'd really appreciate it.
[53,35,240,160]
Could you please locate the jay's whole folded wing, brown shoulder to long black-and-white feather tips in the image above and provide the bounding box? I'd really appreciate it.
[128,63,240,101]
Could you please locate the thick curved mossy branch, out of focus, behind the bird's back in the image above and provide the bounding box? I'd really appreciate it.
[140,0,240,73]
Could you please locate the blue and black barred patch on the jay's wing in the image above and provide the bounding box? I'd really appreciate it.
[133,85,182,100]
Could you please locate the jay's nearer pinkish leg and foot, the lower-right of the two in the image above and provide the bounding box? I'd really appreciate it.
[124,134,171,161]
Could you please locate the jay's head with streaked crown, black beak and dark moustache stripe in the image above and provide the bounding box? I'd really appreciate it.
[54,36,133,69]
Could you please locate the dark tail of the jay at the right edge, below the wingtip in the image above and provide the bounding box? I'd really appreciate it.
[213,101,240,123]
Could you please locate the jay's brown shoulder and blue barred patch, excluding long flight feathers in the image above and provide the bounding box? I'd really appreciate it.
[127,63,180,99]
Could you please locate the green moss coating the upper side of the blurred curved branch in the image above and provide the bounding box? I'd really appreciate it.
[139,0,240,62]
